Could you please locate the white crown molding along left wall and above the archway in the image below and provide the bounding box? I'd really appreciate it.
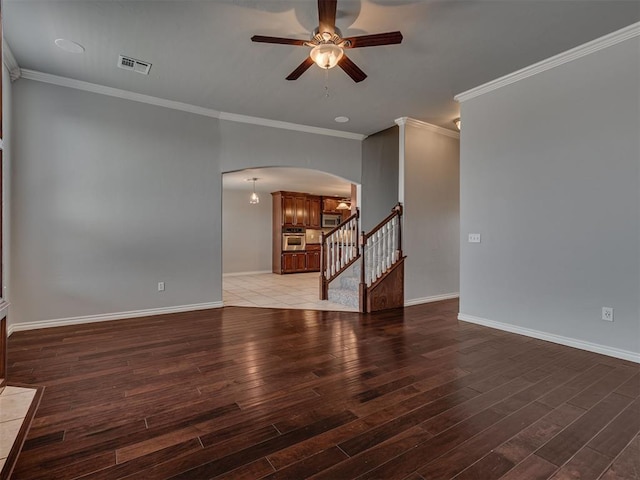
[22,69,367,141]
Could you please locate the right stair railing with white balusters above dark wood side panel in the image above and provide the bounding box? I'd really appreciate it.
[360,203,402,312]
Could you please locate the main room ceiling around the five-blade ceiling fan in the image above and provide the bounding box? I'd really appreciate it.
[2,0,640,134]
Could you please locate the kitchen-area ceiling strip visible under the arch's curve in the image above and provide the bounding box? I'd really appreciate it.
[222,167,351,198]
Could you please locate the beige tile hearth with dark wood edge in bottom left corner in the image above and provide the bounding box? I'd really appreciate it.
[0,386,36,472]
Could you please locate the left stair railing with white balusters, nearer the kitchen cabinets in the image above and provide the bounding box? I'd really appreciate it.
[320,209,360,300]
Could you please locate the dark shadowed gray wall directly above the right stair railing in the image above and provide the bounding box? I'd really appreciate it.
[360,126,400,231]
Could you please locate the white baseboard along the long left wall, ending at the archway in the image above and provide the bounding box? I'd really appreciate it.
[7,302,222,335]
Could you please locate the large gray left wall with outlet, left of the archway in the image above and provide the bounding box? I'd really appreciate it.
[10,79,221,323]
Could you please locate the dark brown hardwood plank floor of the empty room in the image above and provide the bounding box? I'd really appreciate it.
[8,301,640,480]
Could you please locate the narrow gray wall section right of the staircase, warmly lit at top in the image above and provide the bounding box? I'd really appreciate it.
[403,122,460,303]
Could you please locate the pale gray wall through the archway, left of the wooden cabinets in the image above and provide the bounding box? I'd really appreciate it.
[222,188,272,273]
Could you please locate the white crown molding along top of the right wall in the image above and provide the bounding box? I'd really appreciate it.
[453,22,640,102]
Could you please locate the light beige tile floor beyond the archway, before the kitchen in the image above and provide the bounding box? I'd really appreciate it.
[222,273,357,312]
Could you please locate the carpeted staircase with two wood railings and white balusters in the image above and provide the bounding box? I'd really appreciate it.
[320,204,405,313]
